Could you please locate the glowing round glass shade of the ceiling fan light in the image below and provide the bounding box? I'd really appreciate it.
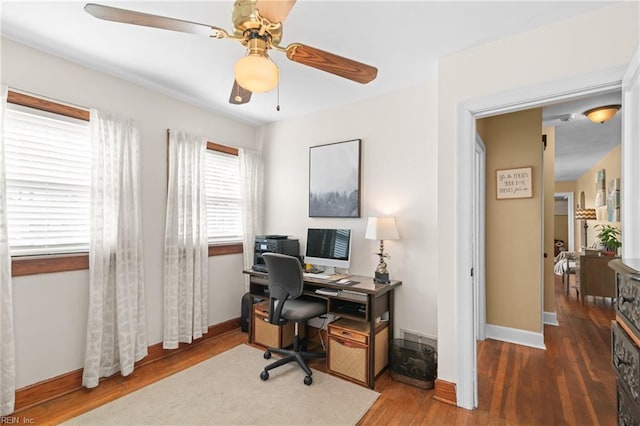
[233,54,279,93]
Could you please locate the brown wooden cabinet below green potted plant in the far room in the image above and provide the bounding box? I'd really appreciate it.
[579,255,616,302]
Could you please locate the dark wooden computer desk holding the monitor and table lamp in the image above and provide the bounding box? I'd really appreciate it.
[243,270,402,389]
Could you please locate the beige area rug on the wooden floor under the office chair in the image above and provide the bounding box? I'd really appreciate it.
[64,345,380,425]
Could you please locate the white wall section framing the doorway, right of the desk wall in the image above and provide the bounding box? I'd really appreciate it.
[437,2,639,382]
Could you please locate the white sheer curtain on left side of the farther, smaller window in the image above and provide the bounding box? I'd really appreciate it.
[162,130,209,349]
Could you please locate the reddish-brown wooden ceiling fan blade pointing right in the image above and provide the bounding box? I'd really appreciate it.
[285,43,378,84]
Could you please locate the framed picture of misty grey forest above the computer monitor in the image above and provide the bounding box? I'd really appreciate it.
[309,139,362,218]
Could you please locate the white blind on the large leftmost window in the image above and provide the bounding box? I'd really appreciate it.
[4,104,91,256]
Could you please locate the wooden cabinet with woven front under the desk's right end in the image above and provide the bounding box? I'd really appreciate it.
[327,318,389,386]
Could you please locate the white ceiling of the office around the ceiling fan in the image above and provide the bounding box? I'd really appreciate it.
[0,0,619,180]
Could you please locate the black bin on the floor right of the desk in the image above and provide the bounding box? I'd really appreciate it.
[390,339,438,389]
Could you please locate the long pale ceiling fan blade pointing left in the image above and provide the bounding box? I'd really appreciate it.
[84,3,226,37]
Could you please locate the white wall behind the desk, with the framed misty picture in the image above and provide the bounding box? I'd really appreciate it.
[261,82,438,337]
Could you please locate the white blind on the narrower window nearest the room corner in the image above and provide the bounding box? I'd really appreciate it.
[205,149,242,244]
